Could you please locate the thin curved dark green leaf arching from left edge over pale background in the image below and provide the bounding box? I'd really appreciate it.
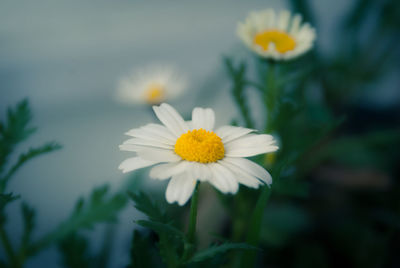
[0,142,61,192]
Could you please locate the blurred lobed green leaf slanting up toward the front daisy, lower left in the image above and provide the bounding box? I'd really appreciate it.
[29,185,127,254]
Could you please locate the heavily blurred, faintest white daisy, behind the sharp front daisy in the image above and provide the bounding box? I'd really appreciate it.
[117,65,187,105]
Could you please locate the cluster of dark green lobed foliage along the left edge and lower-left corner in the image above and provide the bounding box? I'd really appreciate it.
[0,100,127,267]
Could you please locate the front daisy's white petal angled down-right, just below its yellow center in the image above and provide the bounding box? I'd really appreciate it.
[209,163,239,194]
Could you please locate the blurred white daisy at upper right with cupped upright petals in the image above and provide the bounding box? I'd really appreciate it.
[237,9,316,60]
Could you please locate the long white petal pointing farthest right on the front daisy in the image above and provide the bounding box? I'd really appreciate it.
[225,134,278,157]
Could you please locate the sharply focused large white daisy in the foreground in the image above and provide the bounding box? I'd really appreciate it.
[119,103,278,205]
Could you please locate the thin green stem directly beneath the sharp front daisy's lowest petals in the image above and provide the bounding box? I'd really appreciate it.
[181,182,200,264]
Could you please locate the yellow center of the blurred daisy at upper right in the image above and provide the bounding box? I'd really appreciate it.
[253,30,296,53]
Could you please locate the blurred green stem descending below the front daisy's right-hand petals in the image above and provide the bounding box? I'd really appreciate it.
[241,185,272,268]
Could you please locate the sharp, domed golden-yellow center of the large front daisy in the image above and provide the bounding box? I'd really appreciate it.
[174,128,225,163]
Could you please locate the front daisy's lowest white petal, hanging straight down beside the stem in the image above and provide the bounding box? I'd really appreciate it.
[165,173,196,206]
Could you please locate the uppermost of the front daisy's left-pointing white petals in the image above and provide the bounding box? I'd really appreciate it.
[125,124,176,145]
